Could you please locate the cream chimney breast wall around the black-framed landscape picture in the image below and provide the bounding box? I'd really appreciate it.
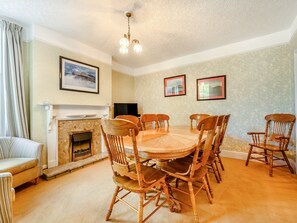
[29,40,112,163]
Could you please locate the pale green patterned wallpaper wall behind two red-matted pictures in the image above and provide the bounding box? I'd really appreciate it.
[135,44,295,158]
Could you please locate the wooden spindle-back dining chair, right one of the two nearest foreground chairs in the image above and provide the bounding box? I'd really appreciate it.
[162,116,218,222]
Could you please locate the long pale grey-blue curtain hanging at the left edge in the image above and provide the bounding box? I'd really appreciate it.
[0,20,29,138]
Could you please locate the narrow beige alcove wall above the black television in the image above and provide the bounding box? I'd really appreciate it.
[111,70,135,117]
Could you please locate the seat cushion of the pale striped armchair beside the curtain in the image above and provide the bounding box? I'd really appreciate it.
[0,158,38,175]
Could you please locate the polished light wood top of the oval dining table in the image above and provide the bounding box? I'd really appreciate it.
[124,126,198,159]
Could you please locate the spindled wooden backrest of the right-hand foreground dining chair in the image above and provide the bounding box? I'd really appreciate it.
[190,116,218,177]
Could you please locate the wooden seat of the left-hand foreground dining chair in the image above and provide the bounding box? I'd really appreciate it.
[113,165,166,193]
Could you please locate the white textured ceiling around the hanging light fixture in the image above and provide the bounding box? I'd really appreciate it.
[0,0,297,68]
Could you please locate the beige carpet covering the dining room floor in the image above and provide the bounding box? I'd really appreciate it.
[13,158,297,223]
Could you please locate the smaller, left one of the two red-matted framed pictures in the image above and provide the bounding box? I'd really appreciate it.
[164,74,186,97]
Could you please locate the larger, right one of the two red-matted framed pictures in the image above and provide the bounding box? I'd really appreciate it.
[197,75,226,101]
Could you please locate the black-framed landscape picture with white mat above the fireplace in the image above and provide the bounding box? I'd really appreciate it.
[60,56,99,94]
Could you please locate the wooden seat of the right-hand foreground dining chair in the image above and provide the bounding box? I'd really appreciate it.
[162,157,208,182]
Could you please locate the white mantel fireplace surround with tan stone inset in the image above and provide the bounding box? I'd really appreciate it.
[40,102,109,168]
